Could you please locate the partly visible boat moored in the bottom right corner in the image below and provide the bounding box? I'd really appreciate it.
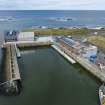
[99,84,105,105]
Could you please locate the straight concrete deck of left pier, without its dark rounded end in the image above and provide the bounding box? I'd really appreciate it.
[4,45,21,81]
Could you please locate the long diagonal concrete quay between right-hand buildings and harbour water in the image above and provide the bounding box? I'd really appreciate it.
[57,44,105,82]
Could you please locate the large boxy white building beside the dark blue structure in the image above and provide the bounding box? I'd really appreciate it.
[17,32,34,41]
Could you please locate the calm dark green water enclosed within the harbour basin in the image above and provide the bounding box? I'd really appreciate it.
[0,48,99,105]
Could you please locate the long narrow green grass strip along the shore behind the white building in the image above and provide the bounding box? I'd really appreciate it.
[24,28,95,37]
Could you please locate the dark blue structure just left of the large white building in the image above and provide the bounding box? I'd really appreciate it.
[4,30,18,42]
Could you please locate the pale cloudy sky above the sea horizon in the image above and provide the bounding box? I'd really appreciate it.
[0,0,105,10]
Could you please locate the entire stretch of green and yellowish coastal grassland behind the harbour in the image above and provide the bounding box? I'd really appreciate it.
[24,28,105,52]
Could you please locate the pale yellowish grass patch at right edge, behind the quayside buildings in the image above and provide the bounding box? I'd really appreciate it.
[88,36,105,52]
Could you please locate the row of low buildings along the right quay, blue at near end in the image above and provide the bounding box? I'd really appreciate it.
[56,37,98,63]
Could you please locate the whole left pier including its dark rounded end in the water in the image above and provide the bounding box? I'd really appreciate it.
[0,45,21,94]
